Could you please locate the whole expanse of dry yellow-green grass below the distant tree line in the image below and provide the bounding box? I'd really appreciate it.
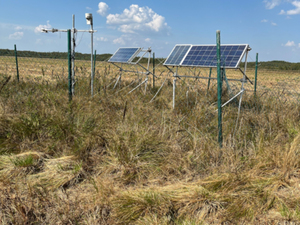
[0,56,300,225]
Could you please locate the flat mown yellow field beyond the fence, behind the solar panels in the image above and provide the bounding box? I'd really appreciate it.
[0,56,300,93]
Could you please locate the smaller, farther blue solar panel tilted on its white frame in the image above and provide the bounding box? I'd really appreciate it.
[108,48,141,63]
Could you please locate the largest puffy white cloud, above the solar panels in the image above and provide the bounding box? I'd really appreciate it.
[106,4,169,33]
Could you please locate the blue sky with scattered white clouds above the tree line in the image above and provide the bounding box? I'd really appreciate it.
[0,0,300,62]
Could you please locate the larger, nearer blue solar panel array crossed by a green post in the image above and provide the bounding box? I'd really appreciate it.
[164,44,249,68]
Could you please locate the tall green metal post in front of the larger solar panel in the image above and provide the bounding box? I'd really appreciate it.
[217,30,223,148]
